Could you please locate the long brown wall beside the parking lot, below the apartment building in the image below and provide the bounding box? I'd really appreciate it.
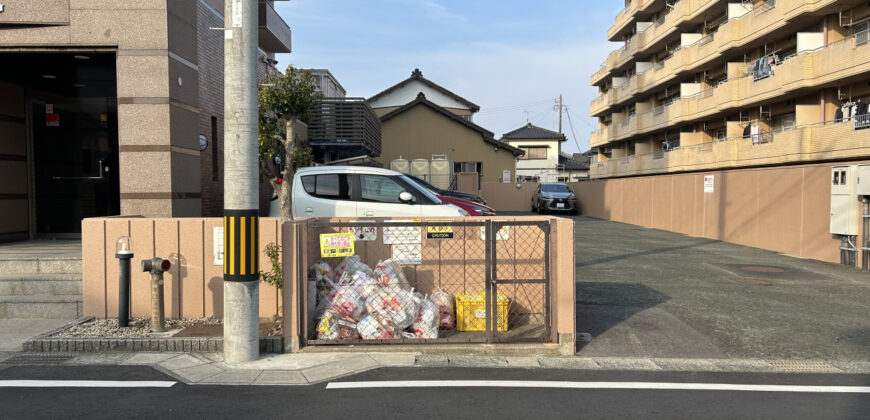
[572,162,863,262]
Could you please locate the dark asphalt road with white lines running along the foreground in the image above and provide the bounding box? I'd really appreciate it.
[0,366,870,419]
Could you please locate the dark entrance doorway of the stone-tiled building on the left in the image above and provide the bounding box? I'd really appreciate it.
[0,51,120,238]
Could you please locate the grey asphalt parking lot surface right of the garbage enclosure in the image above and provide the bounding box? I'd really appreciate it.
[574,216,870,363]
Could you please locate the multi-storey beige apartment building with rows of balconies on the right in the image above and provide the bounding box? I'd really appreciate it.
[590,0,870,178]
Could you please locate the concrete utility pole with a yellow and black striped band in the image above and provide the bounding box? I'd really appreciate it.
[224,0,260,363]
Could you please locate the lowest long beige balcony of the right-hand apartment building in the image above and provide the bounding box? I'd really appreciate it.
[590,121,870,178]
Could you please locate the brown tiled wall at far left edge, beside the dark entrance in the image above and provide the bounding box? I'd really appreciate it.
[0,83,30,240]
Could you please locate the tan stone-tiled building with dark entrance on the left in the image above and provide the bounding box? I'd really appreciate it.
[0,0,291,241]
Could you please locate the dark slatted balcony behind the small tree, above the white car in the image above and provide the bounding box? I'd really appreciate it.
[308,98,381,162]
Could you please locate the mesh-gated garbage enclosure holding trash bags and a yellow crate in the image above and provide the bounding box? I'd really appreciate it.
[298,218,556,345]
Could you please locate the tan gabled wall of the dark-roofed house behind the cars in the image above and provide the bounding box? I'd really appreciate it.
[377,105,516,182]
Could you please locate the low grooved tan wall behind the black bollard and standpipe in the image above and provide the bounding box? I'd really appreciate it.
[82,218,282,318]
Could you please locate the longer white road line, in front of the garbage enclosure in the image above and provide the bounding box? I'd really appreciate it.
[326,381,870,394]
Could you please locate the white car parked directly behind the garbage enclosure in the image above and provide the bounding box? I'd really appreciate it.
[269,166,469,217]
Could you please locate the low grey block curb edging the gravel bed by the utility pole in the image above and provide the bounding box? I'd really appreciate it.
[21,317,284,354]
